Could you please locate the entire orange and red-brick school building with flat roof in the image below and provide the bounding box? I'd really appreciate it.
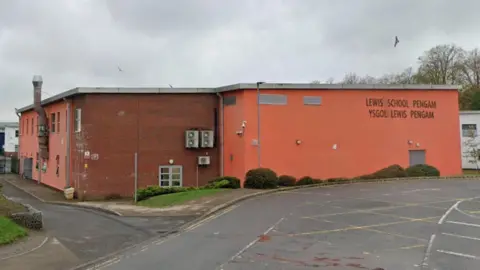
[17,83,462,198]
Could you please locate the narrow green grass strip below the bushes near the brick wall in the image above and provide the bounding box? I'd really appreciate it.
[137,189,230,207]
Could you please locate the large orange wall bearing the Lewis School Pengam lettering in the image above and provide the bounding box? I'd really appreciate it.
[224,90,461,179]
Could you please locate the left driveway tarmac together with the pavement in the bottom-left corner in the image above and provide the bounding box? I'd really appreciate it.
[0,178,195,270]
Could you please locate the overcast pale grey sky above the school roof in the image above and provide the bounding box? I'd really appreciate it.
[0,0,480,121]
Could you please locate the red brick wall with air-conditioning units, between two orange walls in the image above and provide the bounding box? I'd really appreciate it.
[72,94,219,198]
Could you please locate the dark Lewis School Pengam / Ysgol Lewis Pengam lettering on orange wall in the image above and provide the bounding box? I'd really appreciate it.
[365,98,437,119]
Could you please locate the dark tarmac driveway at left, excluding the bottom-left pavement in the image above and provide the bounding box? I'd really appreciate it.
[3,179,194,269]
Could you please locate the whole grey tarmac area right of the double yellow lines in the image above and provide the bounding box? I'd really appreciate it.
[90,180,480,270]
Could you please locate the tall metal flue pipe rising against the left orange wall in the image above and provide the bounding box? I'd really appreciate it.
[32,75,49,159]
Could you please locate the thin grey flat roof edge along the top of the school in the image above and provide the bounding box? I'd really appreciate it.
[16,83,460,113]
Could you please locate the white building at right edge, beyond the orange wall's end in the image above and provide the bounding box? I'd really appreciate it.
[460,111,480,169]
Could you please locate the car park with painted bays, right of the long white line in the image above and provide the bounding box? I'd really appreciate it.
[223,180,480,270]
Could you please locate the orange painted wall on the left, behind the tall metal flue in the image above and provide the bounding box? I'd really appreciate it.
[19,101,67,190]
